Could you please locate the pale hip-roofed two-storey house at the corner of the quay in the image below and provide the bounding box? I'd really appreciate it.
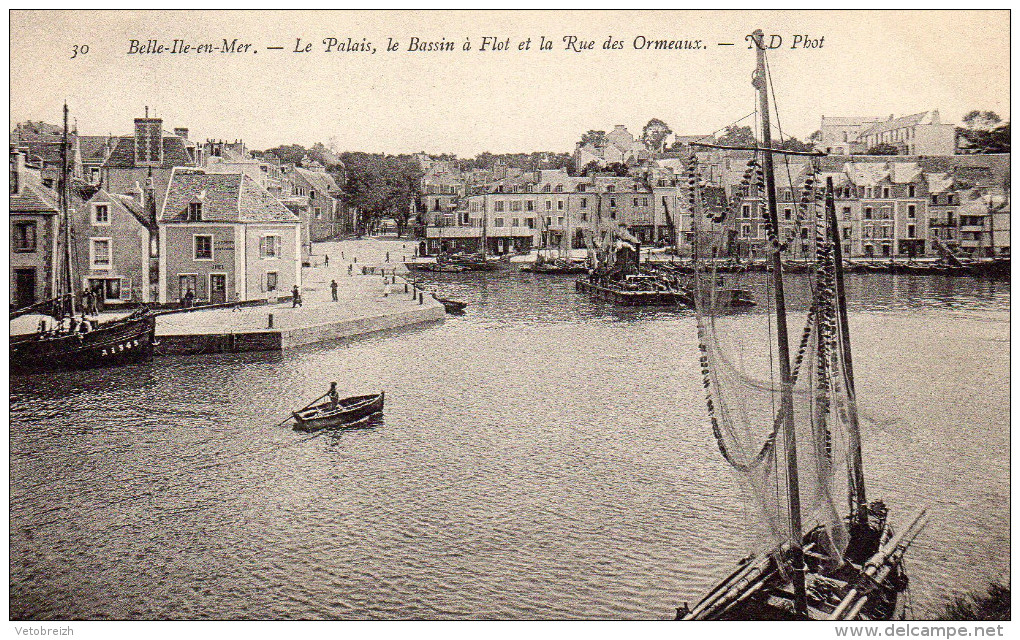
[157,168,301,303]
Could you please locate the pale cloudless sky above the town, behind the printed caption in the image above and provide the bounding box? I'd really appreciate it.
[10,10,1010,157]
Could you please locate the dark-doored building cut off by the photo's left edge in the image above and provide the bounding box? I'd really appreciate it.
[9,150,60,308]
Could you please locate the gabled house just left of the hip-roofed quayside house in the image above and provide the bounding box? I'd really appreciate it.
[70,187,159,305]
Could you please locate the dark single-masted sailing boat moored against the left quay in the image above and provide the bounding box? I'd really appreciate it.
[10,104,156,372]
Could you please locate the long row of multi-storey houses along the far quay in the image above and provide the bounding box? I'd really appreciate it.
[419,151,1009,258]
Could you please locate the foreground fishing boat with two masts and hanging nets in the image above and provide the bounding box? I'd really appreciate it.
[677,31,925,621]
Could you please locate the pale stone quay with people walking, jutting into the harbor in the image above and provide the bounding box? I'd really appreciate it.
[156,239,445,355]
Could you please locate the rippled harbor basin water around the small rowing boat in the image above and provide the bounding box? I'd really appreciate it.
[10,272,1010,620]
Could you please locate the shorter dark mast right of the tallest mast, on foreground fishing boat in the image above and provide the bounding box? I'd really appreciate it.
[825,177,868,527]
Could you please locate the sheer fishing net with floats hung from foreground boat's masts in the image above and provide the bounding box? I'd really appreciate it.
[687,156,855,565]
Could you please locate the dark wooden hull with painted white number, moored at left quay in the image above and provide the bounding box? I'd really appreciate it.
[10,313,156,373]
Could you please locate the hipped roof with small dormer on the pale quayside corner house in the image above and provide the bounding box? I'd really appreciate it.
[159,170,299,223]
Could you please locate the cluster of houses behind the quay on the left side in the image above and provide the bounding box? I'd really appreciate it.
[10,117,357,314]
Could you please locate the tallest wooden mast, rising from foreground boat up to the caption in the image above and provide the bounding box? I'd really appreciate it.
[752,29,808,616]
